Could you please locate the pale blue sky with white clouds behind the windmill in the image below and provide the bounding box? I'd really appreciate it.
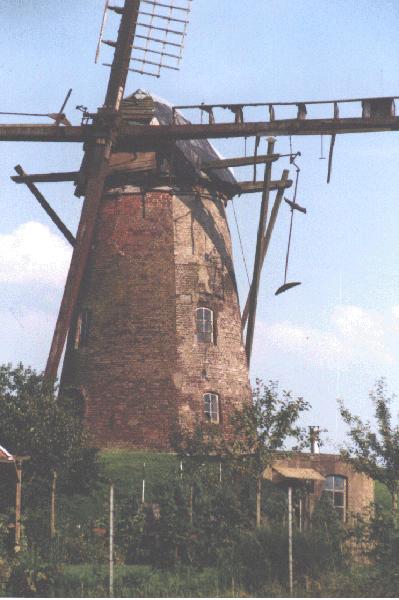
[0,0,399,448]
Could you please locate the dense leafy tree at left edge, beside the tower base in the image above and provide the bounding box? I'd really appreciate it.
[0,364,98,535]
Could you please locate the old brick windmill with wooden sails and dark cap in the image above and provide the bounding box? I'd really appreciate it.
[0,0,399,448]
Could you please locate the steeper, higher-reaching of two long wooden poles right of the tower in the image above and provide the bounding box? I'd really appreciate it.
[245,138,276,366]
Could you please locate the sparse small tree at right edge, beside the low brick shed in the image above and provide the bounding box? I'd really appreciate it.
[339,379,399,511]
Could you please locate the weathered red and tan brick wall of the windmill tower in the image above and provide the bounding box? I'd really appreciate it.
[61,187,250,450]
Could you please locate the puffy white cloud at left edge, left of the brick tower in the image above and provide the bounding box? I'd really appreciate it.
[0,221,71,287]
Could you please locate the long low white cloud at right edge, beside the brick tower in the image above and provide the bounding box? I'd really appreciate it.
[255,305,399,370]
